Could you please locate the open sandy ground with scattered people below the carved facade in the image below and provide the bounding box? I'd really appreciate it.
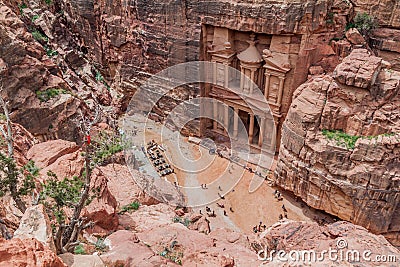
[126,119,333,233]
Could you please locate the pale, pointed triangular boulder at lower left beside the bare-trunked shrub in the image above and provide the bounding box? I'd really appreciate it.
[14,204,56,252]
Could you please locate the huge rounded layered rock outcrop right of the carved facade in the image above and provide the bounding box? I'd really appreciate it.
[275,49,400,247]
